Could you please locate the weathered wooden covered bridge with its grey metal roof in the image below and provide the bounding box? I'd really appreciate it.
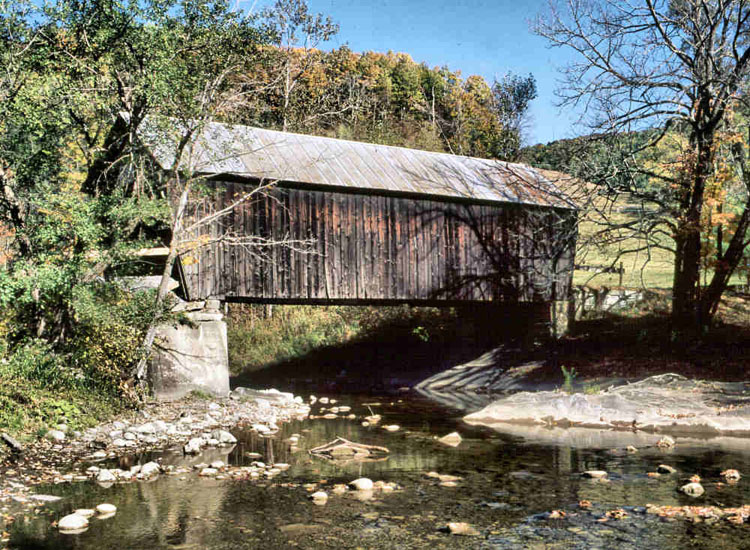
[142,123,576,316]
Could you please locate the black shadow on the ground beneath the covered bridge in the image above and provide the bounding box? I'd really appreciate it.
[231,307,544,394]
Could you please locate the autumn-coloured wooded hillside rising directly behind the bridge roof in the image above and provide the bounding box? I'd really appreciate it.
[226,46,536,160]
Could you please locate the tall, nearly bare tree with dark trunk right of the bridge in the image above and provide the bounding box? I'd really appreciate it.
[535,0,750,328]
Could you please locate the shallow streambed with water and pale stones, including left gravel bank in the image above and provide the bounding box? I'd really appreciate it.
[0,380,750,550]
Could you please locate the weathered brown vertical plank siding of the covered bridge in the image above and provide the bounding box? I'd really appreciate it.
[182,182,575,303]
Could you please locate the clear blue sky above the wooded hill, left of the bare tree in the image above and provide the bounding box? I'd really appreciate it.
[250,0,587,145]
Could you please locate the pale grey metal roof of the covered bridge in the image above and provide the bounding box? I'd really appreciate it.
[141,119,575,208]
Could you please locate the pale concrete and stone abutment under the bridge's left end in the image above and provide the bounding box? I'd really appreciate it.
[149,300,229,401]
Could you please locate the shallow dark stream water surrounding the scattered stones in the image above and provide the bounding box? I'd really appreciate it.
[9,395,750,550]
